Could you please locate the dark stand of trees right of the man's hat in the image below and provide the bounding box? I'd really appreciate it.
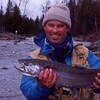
[69,0,100,34]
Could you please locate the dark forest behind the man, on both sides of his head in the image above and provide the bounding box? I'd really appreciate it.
[0,0,100,36]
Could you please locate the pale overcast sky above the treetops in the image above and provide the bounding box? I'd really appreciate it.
[0,0,65,19]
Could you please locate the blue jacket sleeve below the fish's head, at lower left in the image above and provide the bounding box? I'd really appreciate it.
[20,75,53,100]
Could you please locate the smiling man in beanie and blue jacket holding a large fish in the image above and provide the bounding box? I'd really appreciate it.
[20,3,100,100]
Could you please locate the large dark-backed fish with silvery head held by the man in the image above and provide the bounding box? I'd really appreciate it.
[15,59,100,88]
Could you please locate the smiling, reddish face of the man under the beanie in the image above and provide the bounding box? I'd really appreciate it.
[44,20,69,44]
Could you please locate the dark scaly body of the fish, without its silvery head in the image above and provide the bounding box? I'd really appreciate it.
[19,59,100,88]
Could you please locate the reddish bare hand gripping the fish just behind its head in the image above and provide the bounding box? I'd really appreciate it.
[38,68,57,88]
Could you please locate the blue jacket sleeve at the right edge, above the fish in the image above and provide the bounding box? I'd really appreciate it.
[87,51,100,68]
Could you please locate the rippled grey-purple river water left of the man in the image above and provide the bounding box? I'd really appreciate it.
[0,38,36,100]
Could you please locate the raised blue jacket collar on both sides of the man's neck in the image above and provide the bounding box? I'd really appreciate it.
[34,33,73,54]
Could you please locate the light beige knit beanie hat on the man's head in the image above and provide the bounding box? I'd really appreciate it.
[42,3,71,28]
